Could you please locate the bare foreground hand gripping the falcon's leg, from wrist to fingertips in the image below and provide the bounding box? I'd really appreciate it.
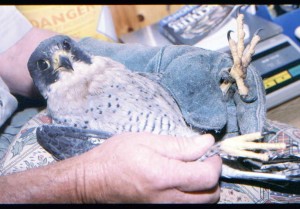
[71,133,221,203]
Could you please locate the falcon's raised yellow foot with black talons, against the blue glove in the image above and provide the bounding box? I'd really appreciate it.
[220,9,260,102]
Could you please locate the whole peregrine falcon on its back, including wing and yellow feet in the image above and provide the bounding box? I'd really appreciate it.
[28,11,294,180]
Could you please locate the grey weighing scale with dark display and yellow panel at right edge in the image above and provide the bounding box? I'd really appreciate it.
[252,34,300,108]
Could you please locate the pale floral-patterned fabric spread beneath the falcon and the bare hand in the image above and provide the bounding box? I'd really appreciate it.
[0,110,300,204]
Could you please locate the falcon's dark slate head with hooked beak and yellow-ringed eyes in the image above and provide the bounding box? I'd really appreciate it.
[27,35,91,99]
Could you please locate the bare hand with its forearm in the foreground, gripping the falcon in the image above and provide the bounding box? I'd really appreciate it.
[0,133,221,203]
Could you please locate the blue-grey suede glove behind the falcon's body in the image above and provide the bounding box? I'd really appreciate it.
[79,38,266,135]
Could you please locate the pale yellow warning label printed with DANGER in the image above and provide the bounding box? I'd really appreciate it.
[17,5,113,40]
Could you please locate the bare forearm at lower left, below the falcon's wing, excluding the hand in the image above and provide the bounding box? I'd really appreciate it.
[0,158,84,203]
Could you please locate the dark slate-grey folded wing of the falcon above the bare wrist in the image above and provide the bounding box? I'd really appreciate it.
[36,125,113,160]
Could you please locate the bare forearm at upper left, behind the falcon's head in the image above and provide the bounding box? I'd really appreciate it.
[0,27,56,97]
